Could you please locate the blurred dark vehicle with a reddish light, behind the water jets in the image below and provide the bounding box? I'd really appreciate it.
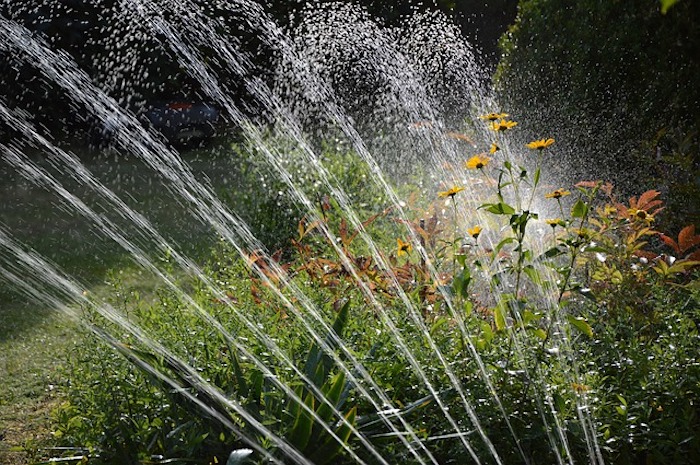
[91,101,220,148]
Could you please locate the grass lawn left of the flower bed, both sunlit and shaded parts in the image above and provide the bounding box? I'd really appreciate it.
[0,141,243,465]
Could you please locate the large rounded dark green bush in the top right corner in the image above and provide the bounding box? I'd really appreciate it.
[496,0,700,228]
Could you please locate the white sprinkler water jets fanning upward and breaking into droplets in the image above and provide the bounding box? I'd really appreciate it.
[0,0,602,463]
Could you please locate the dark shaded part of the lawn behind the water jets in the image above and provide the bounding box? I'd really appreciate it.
[0,140,246,343]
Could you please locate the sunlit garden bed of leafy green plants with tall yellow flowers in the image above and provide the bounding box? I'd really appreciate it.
[56,111,700,464]
